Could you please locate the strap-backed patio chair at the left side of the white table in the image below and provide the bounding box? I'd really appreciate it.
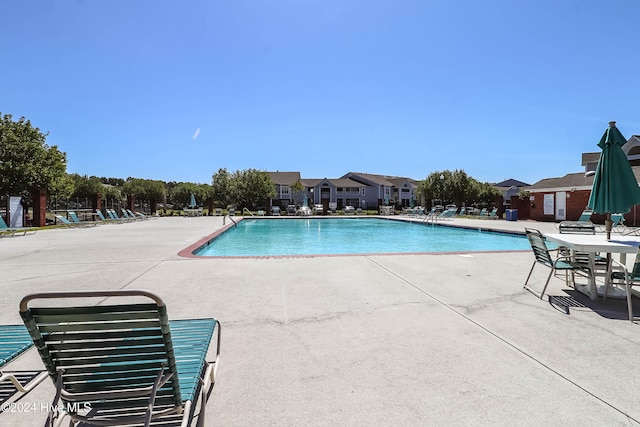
[524,228,591,299]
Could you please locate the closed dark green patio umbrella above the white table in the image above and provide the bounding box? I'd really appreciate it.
[587,122,640,239]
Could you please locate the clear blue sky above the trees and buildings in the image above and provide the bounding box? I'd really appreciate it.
[0,0,640,184]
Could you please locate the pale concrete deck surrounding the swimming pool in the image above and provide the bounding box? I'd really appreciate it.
[0,217,640,426]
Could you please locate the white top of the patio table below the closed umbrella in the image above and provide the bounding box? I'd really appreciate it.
[544,233,640,254]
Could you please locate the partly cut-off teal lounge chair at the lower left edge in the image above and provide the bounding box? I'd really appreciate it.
[0,325,48,408]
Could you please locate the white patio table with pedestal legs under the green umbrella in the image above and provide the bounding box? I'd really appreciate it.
[544,233,640,300]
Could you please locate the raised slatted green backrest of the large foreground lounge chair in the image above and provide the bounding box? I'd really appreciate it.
[20,291,182,418]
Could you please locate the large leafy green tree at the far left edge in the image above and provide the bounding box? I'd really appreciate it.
[0,113,69,196]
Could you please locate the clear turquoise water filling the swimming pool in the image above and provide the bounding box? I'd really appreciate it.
[195,218,531,257]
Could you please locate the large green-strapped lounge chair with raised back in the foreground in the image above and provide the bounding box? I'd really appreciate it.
[20,290,220,426]
